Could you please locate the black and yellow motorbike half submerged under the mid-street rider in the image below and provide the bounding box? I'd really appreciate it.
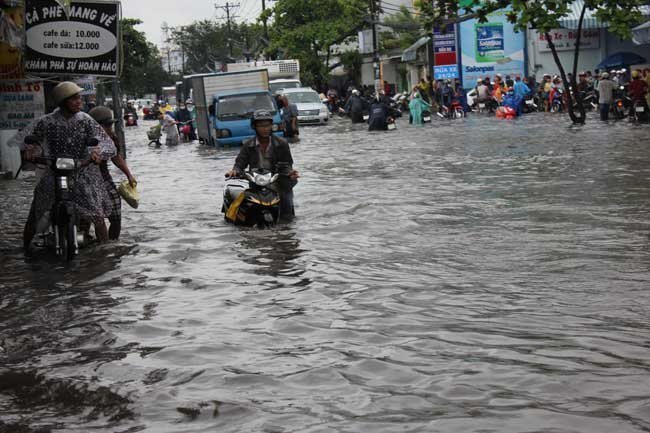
[221,169,280,228]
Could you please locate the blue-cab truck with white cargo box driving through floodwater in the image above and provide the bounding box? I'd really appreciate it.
[184,69,281,145]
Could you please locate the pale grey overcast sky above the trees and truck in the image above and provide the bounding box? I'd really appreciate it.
[122,0,264,46]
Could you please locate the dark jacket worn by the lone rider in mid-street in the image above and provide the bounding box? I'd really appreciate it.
[233,135,297,191]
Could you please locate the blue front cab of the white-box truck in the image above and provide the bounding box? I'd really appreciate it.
[210,89,282,146]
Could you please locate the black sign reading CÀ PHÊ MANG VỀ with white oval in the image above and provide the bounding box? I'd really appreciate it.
[25,0,120,77]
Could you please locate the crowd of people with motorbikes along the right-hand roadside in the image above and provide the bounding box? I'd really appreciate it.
[323,68,650,124]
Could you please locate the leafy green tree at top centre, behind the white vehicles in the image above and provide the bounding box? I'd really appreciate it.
[260,0,370,87]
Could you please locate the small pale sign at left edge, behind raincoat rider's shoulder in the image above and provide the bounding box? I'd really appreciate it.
[0,80,45,129]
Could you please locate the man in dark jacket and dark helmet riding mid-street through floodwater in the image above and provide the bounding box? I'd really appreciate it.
[226,110,300,219]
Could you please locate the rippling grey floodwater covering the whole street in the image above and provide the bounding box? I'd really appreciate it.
[0,114,650,433]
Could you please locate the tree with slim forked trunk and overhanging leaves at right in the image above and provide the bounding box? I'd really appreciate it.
[417,0,645,123]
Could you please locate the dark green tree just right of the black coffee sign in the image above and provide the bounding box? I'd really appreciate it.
[120,18,171,97]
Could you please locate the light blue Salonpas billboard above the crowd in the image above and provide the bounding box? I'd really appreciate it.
[459,9,525,88]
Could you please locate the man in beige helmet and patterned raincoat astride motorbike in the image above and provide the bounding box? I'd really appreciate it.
[21,81,116,252]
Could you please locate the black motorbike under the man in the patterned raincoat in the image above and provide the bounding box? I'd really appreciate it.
[16,136,98,260]
